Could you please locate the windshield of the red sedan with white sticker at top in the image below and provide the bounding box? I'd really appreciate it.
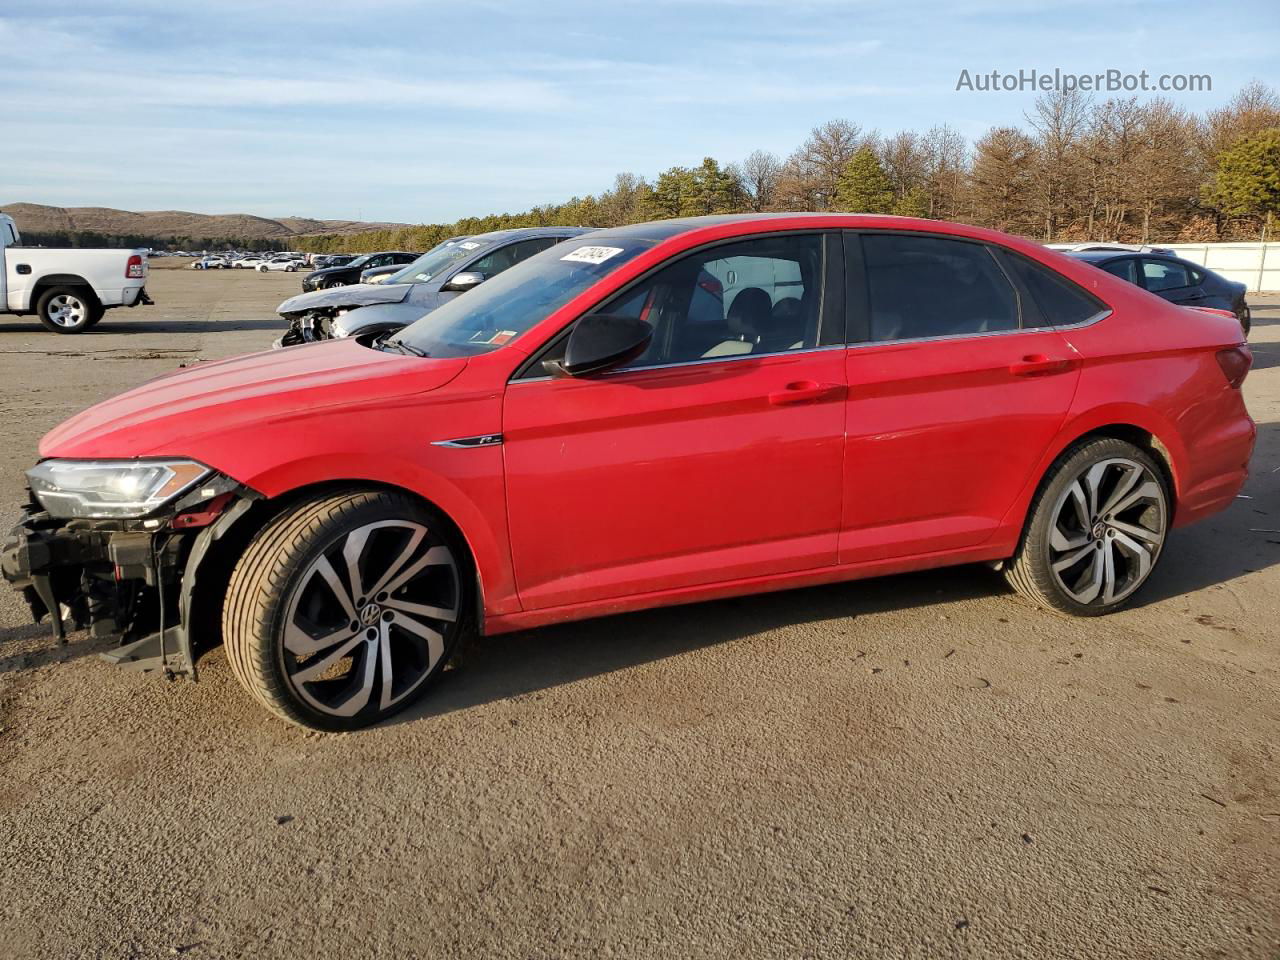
[388,236,654,357]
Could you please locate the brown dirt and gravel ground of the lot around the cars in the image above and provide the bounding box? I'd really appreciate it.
[0,270,1280,960]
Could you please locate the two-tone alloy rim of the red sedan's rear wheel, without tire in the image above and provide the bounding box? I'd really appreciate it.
[1048,457,1169,605]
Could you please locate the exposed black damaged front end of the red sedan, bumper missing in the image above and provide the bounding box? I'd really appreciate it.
[0,461,261,680]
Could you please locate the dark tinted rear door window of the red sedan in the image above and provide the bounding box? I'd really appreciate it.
[863,234,1018,340]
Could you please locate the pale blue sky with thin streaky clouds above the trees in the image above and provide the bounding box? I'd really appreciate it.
[0,0,1280,223]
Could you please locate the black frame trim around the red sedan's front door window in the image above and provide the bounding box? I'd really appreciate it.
[507,228,847,384]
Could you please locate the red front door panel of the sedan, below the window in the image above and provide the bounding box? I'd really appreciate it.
[503,348,845,609]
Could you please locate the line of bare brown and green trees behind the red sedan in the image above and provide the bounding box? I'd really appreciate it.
[292,82,1280,252]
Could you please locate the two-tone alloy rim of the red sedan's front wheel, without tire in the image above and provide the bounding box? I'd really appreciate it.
[282,520,462,717]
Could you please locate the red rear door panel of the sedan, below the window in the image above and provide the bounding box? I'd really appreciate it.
[840,330,1079,563]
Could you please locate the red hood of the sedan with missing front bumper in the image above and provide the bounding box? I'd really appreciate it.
[40,339,467,468]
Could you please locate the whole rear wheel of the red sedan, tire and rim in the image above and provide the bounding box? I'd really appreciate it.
[1005,438,1172,617]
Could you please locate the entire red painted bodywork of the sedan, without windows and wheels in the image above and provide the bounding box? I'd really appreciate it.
[41,214,1254,632]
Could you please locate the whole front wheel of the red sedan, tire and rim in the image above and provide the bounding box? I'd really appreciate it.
[223,490,471,731]
